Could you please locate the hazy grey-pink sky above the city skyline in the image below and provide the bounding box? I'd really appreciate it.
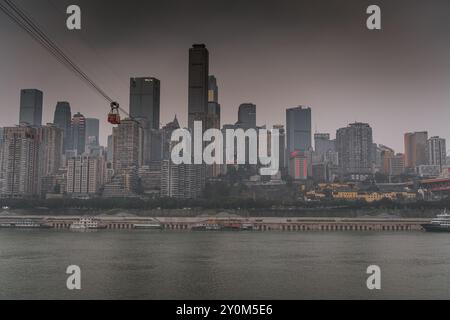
[0,0,450,152]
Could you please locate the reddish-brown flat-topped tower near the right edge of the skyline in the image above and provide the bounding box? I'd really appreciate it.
[405,131,428,169]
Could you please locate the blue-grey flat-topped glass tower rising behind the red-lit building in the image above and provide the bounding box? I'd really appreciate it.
[286,106,311,154]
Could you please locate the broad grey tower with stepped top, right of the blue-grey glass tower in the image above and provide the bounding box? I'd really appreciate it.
[336,122,373,175]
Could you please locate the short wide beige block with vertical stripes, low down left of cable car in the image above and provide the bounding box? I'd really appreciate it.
[66,155,106,197]
